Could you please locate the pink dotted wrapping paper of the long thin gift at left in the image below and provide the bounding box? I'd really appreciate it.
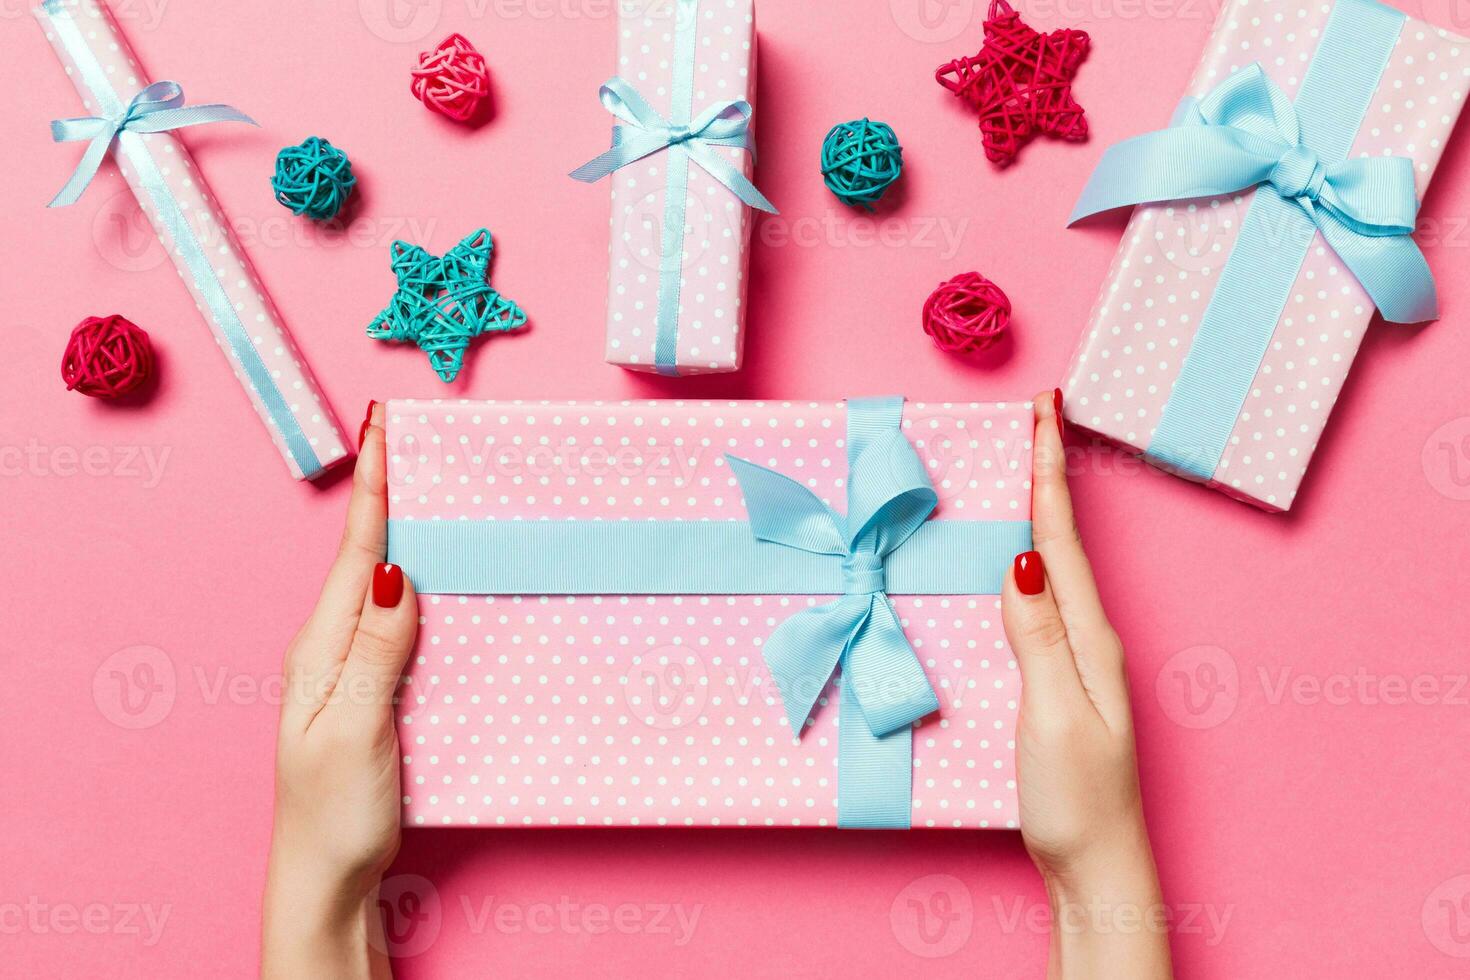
[34,0,350,479]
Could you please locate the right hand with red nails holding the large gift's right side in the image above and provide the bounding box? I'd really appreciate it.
[1001,391,1172,979]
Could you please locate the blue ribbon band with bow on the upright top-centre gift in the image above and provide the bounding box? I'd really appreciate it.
[572,0,778,376]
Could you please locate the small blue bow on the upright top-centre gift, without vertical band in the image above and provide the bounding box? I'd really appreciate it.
[572,78,776,215]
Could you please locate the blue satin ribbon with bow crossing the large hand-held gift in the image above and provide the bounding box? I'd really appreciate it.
[388,398,1032,827]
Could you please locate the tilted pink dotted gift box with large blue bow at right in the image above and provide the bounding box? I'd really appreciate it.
[1064,0,1470,511]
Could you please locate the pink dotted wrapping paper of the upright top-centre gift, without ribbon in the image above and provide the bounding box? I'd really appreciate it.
[606,0,756,375]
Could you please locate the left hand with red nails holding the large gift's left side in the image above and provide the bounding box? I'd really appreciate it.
[262,403,419,977]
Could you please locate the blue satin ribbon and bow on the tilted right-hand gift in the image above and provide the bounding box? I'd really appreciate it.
[1070,0,1438,480]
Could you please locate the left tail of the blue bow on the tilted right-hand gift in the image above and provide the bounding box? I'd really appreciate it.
[1067,126,1285,225]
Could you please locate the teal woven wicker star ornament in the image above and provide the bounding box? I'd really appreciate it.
[368,228,526,382]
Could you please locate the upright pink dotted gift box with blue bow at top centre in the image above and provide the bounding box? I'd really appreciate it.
[572,0,775,375]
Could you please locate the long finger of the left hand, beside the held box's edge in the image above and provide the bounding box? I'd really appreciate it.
[288,401,388,696]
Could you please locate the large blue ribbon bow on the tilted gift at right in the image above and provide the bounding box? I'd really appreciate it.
[1069,63,1438,323]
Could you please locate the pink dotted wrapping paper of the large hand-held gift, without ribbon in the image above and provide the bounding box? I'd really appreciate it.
[387,401,1032,827]
